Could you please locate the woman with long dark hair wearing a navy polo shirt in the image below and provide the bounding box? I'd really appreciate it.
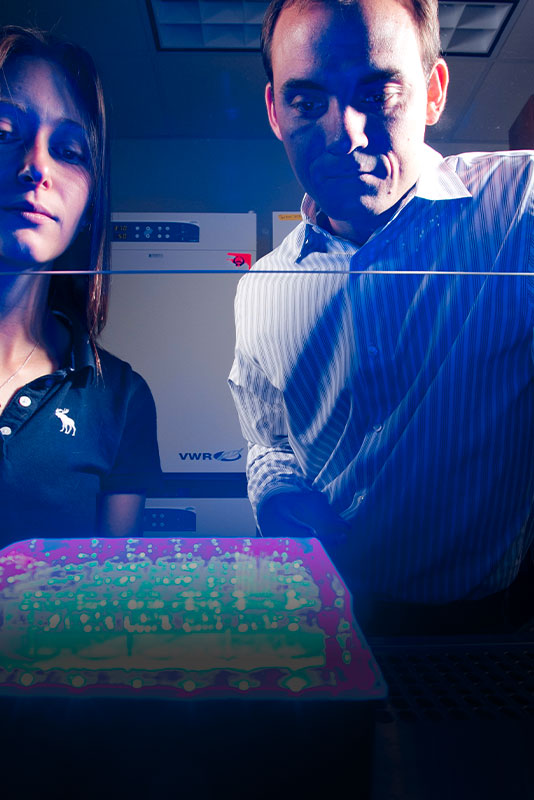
[0,26,159,546]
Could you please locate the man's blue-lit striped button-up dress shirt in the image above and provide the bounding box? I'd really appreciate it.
[229,147,534,603]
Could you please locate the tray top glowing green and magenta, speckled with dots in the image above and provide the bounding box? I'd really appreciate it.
[0,538,386,700]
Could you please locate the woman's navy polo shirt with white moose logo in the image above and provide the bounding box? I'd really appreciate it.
[0,318,160,547]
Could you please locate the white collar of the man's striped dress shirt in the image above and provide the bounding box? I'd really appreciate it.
[297,144,472,262]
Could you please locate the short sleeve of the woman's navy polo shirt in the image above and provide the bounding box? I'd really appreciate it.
[101,372,161,494]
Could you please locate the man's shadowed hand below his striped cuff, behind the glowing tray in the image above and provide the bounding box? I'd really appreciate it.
[258,492,349,544]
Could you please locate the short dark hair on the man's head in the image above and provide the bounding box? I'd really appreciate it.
[261,0,441,83]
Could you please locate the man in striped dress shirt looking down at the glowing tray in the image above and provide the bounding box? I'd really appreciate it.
[230,0,534,622]
